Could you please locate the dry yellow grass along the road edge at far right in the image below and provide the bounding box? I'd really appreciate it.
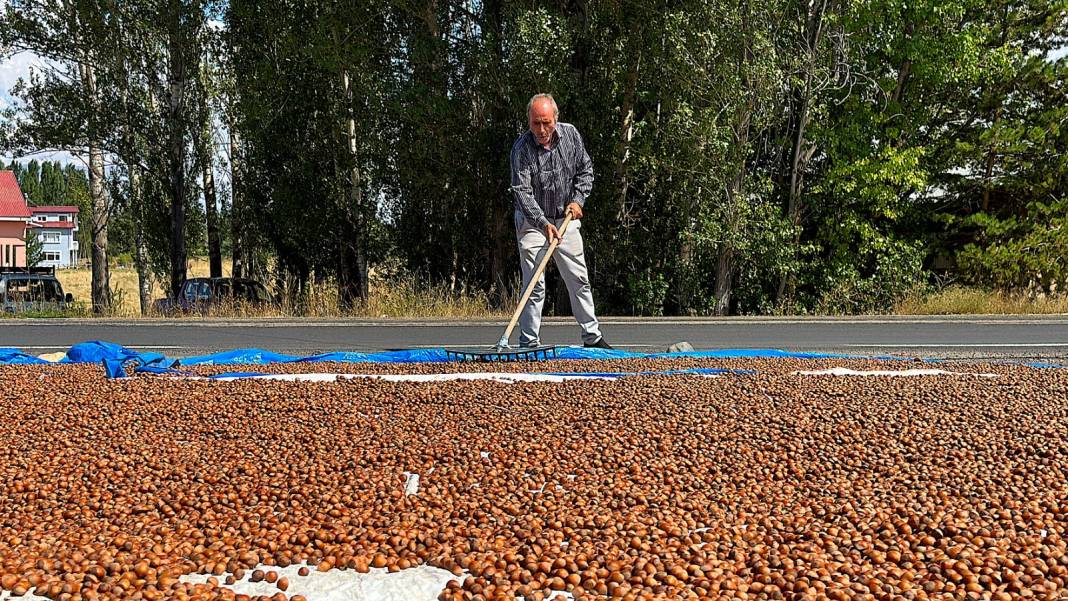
[892,286,1068,315]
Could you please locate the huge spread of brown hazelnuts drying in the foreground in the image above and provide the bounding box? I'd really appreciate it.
[0,360,1068,601]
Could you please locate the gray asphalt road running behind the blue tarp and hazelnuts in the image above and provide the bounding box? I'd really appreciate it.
[0,316,1068,359]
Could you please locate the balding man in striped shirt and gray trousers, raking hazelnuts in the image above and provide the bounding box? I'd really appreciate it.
[511,94,612,349]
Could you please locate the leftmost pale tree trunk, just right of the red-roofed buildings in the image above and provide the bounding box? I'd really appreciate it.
[79,64,111,315]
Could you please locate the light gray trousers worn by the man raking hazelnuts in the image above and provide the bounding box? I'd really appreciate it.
[516,211,601,346]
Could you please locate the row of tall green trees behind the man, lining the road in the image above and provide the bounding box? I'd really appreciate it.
[0,0,1068,315]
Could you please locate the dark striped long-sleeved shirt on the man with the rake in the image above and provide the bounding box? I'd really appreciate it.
[511,123,594,228]
